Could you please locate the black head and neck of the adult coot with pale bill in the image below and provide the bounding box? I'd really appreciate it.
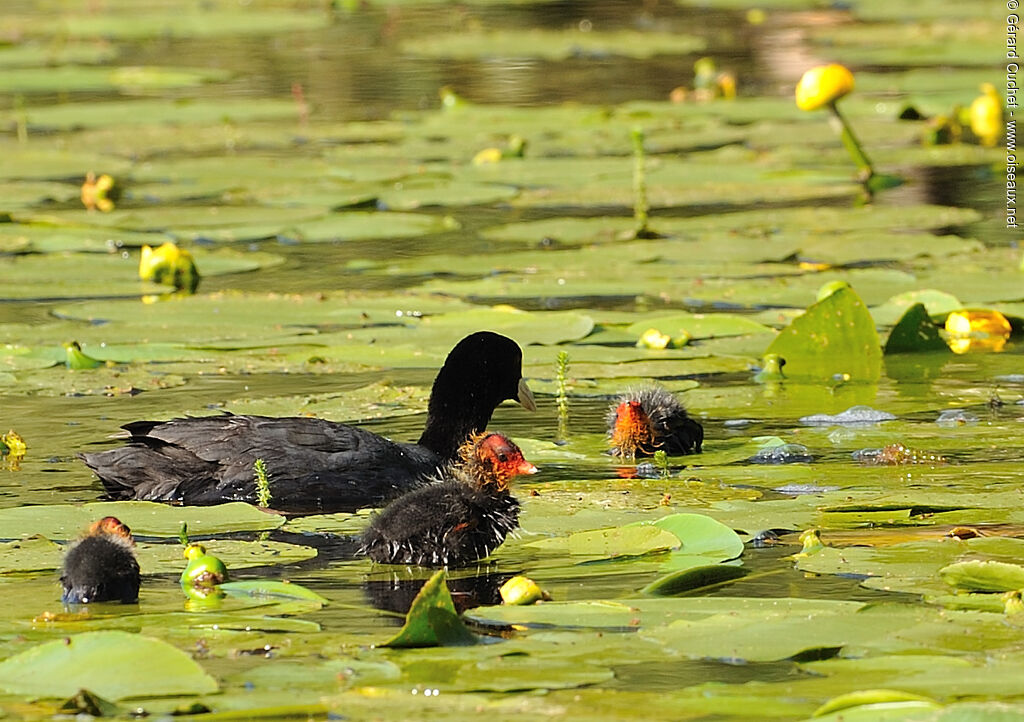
[420,331,537,461]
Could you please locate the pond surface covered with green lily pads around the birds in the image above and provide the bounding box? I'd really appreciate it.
[0,0,1024,720]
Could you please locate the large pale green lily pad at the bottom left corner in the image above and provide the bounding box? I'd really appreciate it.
[0,631,217,699]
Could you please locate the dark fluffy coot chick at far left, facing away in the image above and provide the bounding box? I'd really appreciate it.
[60,516,140,604]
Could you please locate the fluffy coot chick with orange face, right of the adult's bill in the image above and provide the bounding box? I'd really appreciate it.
[607,386,703,459]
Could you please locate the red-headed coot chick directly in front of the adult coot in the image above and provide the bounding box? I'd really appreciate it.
[361,433,537,566]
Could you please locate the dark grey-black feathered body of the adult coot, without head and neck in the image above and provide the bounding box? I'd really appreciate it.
[82,416,440,513]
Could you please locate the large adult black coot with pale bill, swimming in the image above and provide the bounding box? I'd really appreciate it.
[81,331,536,514]
